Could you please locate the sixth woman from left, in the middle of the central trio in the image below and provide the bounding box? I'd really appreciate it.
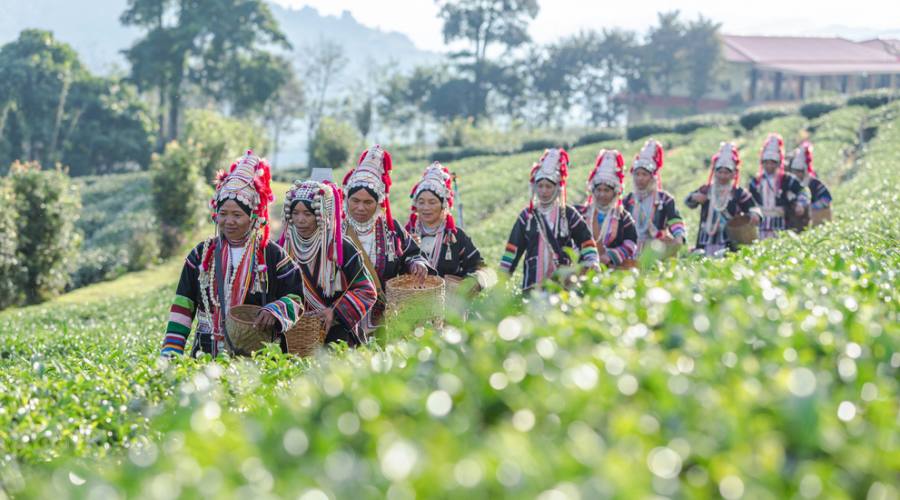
[579,149,638,267]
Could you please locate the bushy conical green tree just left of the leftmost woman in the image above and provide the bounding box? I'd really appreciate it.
[150,141,206,259]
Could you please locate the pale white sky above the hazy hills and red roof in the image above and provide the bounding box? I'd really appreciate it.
[274,0,900,52]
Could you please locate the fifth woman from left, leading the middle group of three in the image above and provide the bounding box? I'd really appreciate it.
[500,149,598,291]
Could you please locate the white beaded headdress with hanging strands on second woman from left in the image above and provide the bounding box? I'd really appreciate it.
[278,180,344,296]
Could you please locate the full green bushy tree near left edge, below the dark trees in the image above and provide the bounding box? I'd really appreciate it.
[8,162,81,304]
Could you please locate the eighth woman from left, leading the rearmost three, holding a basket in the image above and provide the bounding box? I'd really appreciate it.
[685,142,760,256]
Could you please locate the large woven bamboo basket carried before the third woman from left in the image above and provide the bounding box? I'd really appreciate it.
[385,274,446,324]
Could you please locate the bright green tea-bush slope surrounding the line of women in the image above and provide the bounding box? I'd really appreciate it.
[0,103,900,499]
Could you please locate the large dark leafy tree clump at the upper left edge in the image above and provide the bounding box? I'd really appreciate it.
[0,30,153,175]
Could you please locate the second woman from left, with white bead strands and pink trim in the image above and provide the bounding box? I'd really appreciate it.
[279,181,376,346]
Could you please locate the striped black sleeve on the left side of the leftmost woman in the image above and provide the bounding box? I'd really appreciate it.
[161,247,200,356]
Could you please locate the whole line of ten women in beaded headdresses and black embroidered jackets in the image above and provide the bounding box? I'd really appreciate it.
[162,134,831,356]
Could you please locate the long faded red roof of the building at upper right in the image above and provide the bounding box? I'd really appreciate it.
[722,35,900,75]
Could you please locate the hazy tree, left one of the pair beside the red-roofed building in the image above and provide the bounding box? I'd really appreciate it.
[644,10,685,96]
